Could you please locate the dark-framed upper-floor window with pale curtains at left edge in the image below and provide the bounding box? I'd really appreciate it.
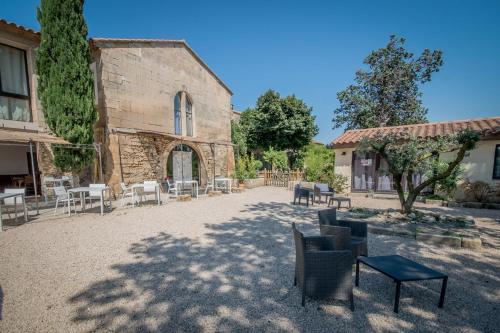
[0,44,32,122]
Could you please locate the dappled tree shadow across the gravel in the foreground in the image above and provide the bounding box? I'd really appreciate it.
[69,202,497,332]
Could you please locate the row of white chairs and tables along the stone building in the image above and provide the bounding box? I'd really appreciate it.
[0,176,240,231]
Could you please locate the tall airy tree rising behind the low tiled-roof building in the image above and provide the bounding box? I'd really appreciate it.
[333,35,443,129]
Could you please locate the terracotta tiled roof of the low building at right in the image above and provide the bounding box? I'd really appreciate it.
[332,117,500,148]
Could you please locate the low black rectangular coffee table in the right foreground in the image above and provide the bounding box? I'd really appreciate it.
[356,255,448,313]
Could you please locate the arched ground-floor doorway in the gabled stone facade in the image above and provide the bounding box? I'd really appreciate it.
[167,143,201,184]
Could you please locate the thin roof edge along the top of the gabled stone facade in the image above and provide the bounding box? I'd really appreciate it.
[90,38,233,95]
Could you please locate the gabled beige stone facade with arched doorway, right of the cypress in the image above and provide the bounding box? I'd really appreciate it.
[91,38,234,191]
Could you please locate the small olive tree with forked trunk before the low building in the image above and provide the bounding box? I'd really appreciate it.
[359,129,479,214]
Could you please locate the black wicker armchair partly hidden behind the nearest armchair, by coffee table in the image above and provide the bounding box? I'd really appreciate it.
[318,208,368,262]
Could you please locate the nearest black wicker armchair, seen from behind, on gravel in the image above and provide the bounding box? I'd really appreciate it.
[292,223,354,311]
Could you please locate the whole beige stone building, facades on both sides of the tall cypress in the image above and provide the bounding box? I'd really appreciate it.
[0,20,234,191]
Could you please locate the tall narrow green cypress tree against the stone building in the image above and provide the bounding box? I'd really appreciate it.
[36,0,97,171]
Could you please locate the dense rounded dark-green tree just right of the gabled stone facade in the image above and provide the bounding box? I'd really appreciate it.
[244,90,318,151]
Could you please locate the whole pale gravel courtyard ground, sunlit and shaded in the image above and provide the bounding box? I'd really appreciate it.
[0,188,500,332]
